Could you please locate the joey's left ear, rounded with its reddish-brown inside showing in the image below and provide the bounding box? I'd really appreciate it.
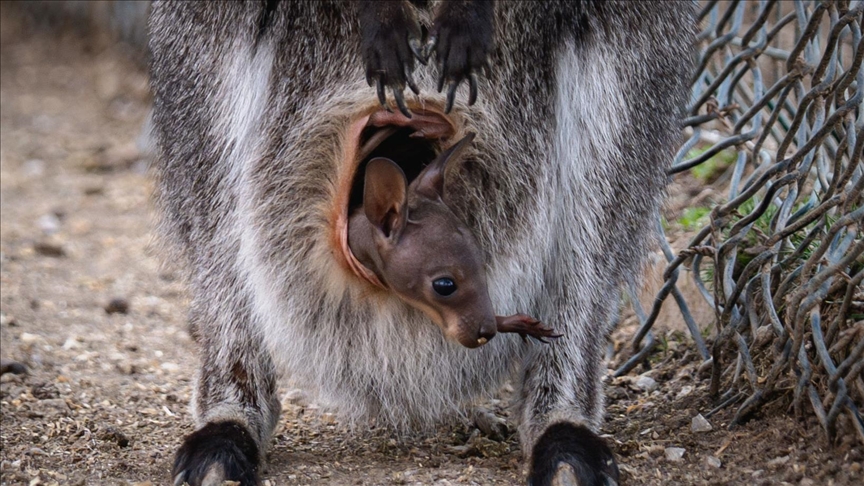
[363,157,408,238]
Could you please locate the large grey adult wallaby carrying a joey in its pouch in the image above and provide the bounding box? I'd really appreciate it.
[150,0,695,485]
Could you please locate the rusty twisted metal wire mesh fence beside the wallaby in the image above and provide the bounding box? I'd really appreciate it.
[615,0,864,441]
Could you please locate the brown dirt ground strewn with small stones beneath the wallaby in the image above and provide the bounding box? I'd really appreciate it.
[0,6,864,486]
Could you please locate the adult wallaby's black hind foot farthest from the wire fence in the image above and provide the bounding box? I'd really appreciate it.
[172,422,259,486]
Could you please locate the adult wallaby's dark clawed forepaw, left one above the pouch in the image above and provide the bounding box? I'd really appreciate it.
[358,1,422,118]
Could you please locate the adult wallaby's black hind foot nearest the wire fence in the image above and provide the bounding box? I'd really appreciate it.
[528,422,618,486]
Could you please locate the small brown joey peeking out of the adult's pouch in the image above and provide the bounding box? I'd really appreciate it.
[348,133,561,348]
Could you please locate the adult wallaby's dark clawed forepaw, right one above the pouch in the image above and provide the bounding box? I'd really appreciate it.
[424,0,495,113]
